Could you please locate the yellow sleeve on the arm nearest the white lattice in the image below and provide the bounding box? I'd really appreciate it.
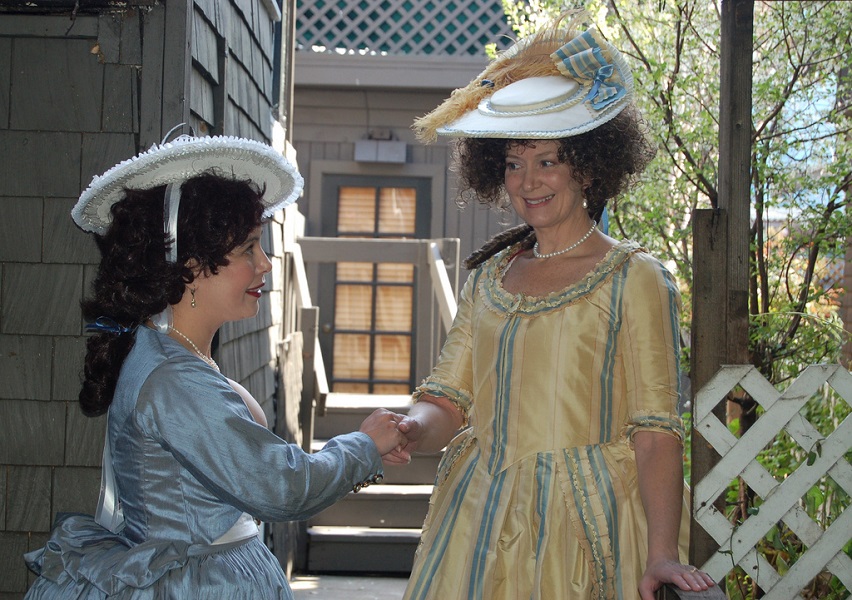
[622,252,683,440]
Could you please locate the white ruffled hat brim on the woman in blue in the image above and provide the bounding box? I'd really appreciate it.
[71,136,304,235]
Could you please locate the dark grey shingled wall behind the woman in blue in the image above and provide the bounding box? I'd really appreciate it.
[0,0,292,600]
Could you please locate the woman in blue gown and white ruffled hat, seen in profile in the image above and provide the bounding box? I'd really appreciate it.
[21,136,401,599]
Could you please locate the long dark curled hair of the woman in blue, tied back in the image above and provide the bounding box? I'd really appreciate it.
[79,173,263,417]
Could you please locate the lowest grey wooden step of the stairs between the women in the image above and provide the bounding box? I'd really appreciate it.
[308,527,420,574]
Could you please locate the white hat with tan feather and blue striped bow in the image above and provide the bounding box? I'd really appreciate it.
[415,11,633,141]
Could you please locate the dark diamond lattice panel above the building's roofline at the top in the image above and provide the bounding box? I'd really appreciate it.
[296,0,512,56]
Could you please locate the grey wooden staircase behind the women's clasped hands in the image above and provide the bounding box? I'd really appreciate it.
[307,393,440,574]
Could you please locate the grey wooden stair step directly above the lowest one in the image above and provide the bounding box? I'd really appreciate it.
[308,484,432,529]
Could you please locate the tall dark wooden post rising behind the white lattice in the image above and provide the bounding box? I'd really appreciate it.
[689,0,754,583]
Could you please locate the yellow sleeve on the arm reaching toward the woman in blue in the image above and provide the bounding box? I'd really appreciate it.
[413,267,482,425]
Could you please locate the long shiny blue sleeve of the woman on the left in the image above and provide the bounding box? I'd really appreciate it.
[135,357,381,521]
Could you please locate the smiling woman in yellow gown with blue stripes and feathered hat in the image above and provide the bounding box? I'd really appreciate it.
[390,10,712,600]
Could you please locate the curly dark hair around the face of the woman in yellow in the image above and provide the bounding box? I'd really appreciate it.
[454,104,656,221]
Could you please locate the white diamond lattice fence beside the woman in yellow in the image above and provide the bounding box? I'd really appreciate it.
[693,365,852,600]
